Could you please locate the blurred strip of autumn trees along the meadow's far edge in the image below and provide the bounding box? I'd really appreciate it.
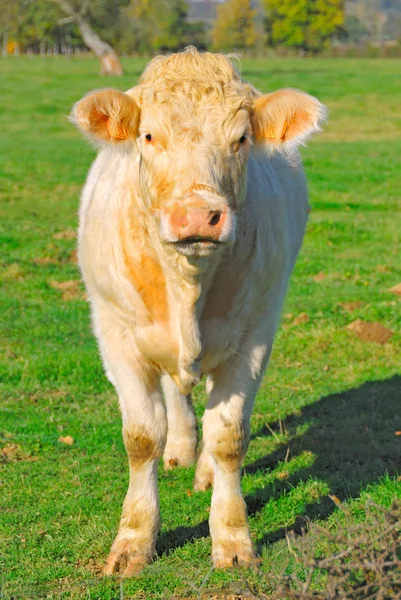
[0,0,401,66]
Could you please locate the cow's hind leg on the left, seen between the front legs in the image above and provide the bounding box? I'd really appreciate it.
[162,375,197,470]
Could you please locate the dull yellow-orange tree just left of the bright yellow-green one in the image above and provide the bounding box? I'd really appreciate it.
[212,0,260,51]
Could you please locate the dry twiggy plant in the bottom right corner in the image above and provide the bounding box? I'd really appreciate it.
[272,501,401,600]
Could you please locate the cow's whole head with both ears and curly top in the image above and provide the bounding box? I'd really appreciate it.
[72,49,325,256]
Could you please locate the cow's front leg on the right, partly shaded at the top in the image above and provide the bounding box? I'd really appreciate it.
[200,338,268,568]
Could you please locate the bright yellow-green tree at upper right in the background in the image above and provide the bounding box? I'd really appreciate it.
[264,0,344,52]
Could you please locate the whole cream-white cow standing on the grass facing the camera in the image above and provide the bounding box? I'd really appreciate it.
[72,48,325,576]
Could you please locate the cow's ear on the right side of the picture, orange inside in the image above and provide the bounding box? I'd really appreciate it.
[252,89,327,147]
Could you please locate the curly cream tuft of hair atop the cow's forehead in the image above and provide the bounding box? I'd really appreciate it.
[134,48,259,143]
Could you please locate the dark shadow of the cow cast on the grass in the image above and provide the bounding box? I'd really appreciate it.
[157,376,401,553]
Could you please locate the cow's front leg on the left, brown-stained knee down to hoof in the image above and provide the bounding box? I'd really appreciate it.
[100,332,167,577]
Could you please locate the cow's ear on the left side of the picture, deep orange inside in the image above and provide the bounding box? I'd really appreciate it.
[71,89,140,143]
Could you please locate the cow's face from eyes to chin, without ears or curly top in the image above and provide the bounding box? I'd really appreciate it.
[132,89,252,255]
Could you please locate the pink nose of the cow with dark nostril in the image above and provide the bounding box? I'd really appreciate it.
[170,206,227,242]
